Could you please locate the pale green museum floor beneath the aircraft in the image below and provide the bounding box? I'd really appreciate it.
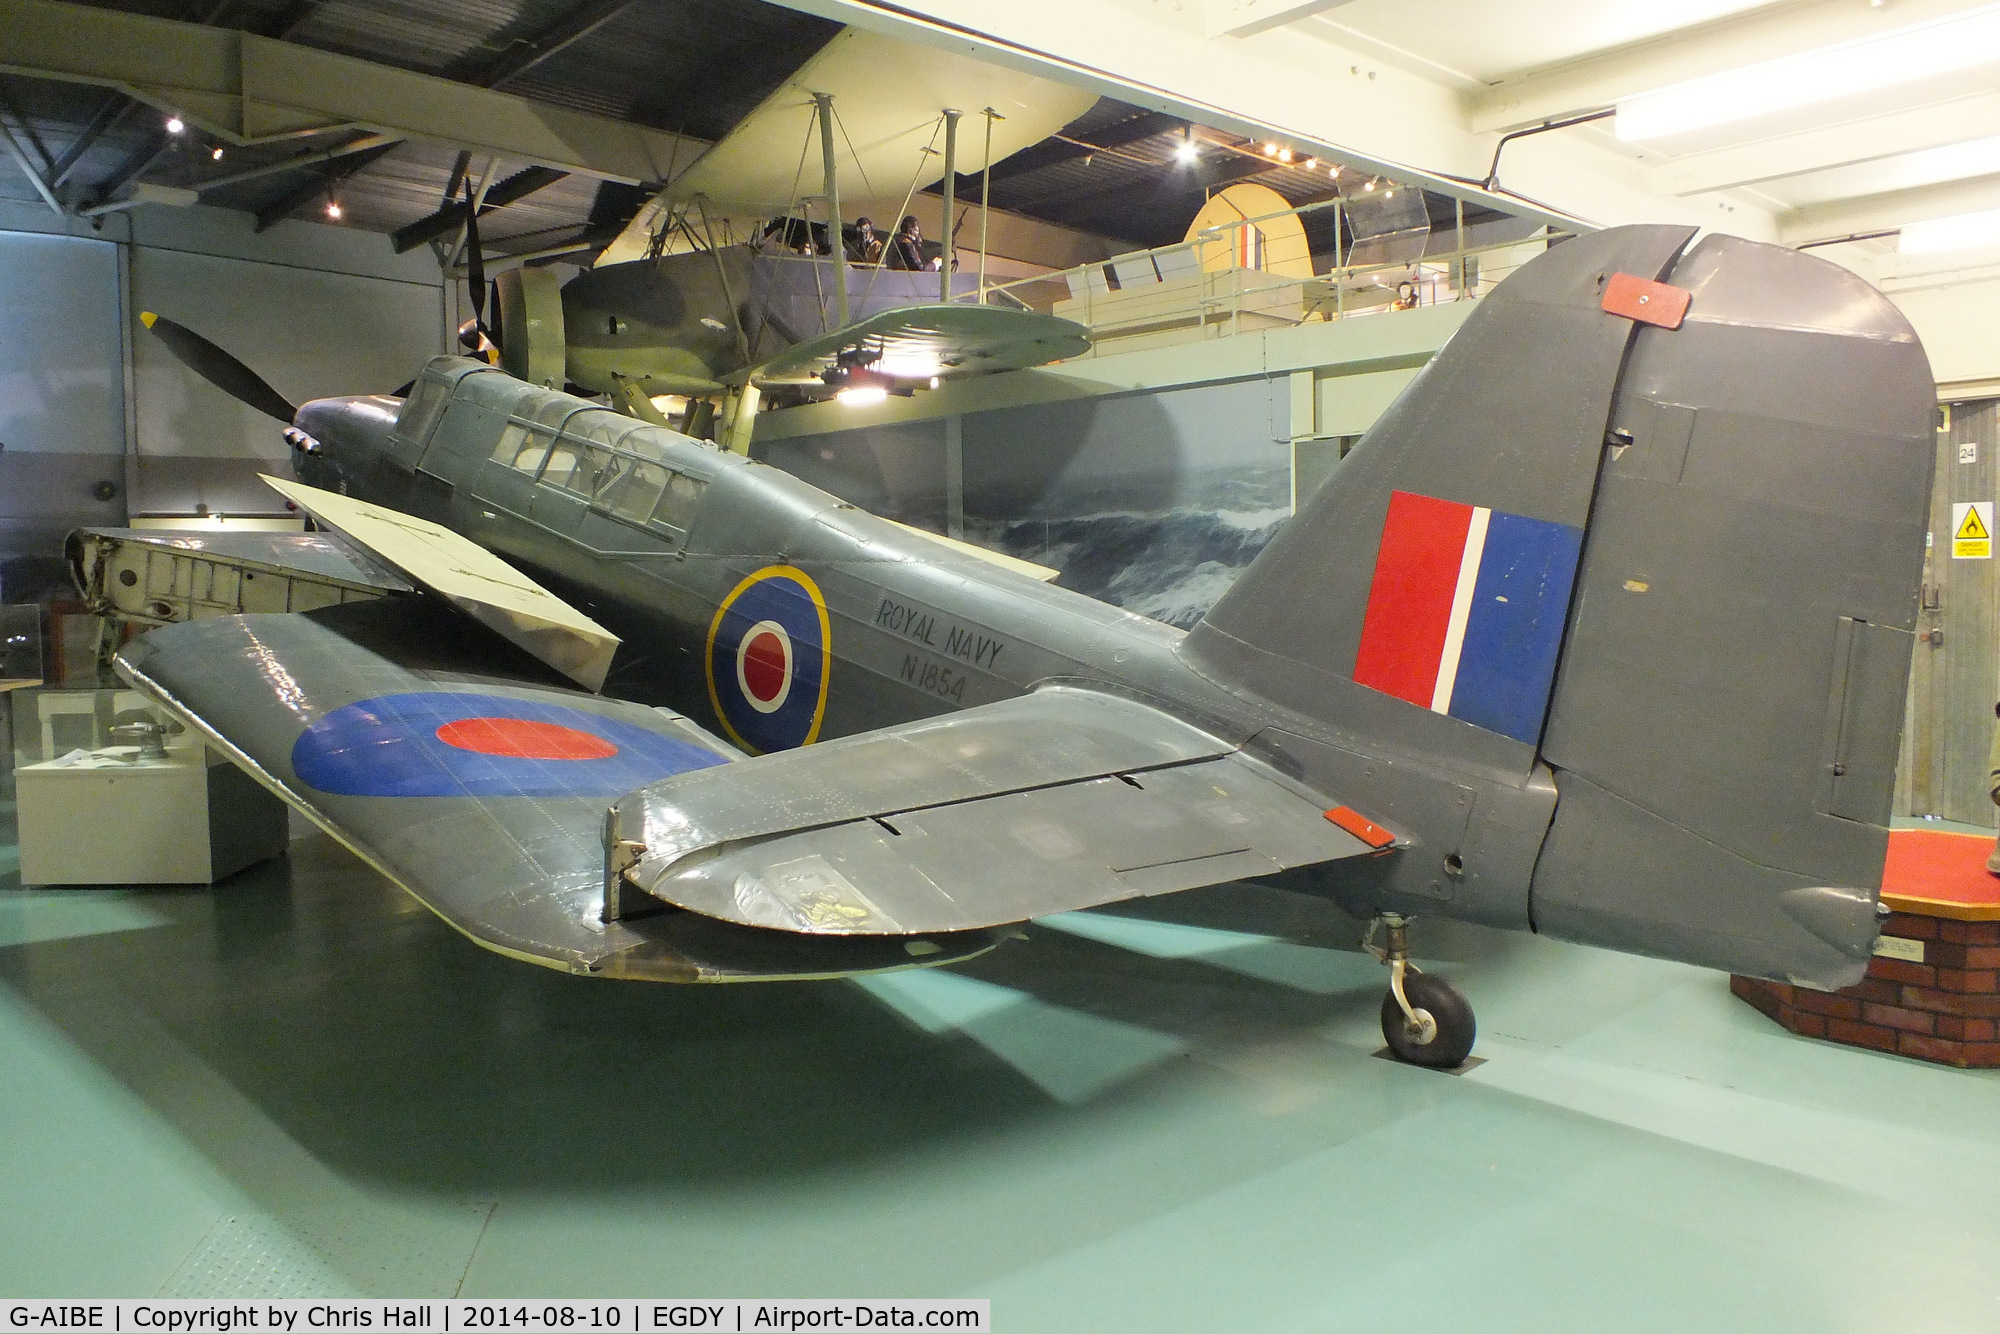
[0,812,2000,1334]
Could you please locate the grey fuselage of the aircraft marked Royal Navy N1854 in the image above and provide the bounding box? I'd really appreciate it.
[298,358,1504,926]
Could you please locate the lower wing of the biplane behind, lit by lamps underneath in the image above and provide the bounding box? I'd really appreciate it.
[736,302,1090,394]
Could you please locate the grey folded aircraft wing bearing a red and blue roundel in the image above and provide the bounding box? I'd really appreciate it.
[118,598,994,982]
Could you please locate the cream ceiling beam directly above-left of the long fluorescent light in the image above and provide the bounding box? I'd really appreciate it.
[1472,0,1968,134]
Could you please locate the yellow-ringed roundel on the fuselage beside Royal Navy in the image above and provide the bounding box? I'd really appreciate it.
[708,566,832,752]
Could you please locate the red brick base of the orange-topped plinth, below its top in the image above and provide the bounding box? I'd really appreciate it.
[1730,912,2000,1068]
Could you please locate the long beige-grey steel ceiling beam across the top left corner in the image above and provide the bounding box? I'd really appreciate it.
[0,0,686,184]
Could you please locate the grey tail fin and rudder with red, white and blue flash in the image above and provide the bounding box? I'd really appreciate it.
[1184,226,1934,986]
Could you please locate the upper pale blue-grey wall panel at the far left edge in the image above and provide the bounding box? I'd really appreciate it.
[0,232,124,460]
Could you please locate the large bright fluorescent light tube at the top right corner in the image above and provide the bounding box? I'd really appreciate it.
[1614,4,2000,142]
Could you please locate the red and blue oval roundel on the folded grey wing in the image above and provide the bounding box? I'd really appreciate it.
[292,690,726,798]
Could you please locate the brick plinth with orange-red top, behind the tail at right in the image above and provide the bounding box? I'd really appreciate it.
[1730,830,2000,1068]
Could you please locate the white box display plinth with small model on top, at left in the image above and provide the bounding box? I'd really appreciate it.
[14,690,288,886]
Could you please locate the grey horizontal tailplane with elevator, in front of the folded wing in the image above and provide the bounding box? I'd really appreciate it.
[612,686,1386,938]
